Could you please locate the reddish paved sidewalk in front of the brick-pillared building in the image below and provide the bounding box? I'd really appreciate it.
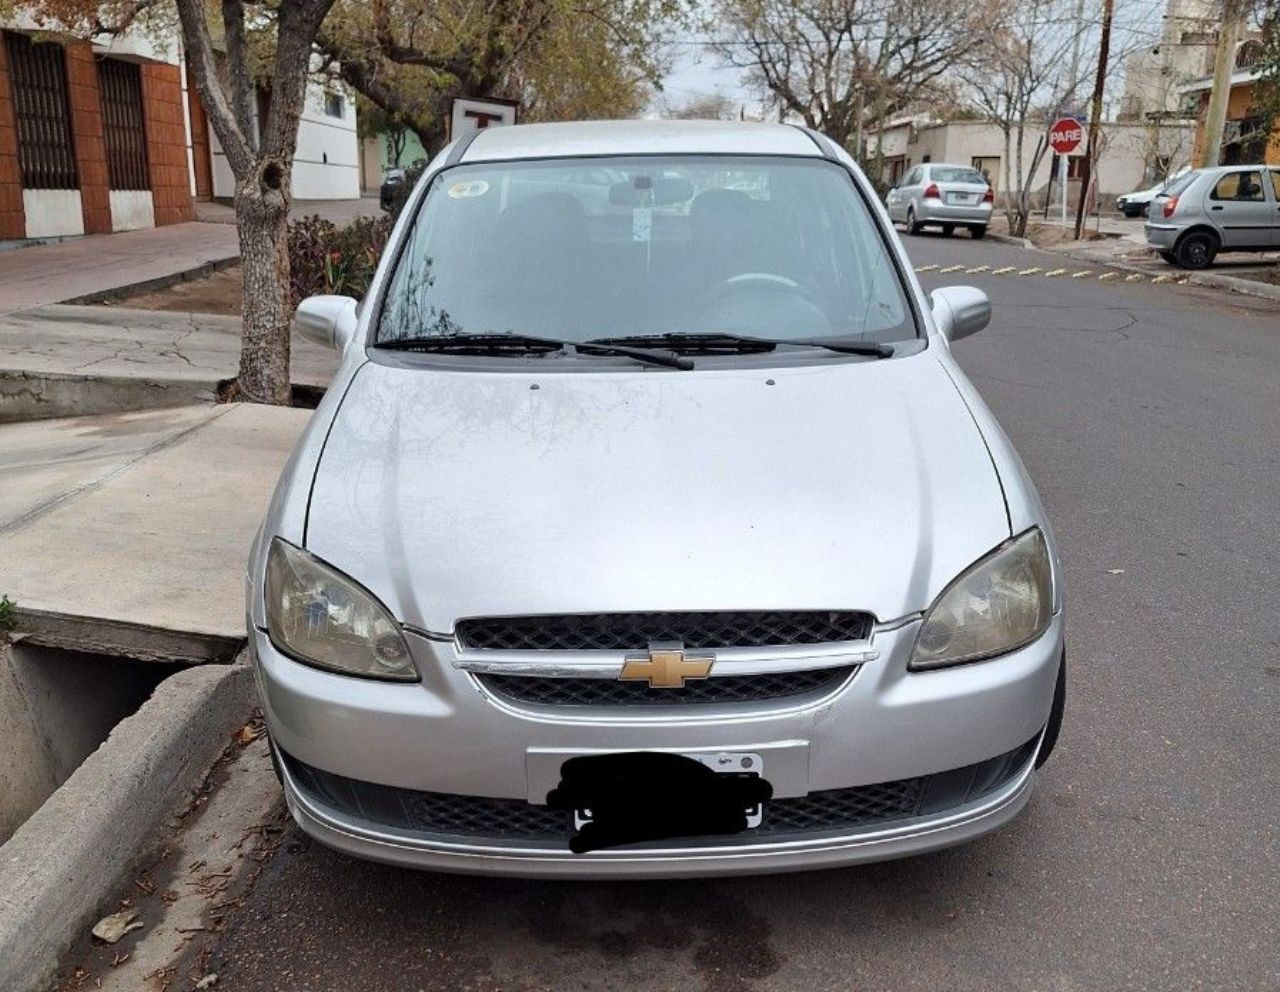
[0,223,239,315]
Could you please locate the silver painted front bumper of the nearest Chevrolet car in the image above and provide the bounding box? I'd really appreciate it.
[251,616,1062,878]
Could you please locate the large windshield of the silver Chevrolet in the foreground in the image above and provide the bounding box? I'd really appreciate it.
[376,156,916,342]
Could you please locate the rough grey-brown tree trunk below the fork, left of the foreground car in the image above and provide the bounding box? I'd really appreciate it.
[236,163,293,406]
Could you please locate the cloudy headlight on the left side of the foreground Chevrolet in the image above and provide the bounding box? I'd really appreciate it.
[266,538,419,682]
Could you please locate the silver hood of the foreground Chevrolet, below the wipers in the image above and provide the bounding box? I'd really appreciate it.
[306,351,1009,632]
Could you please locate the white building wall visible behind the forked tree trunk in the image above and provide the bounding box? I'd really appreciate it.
[209,83,360,200]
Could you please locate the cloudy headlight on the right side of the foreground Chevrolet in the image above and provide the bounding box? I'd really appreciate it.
[908,527,1053,671]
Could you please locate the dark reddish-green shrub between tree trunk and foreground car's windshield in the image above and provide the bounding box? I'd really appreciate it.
[289,216,392,306]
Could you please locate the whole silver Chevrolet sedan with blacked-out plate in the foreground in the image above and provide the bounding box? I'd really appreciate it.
[247,122,1066,878]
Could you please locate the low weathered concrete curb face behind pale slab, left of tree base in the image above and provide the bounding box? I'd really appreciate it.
[0,369,218,424]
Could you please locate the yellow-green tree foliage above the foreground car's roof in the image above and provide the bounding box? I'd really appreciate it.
[317,0,699,155]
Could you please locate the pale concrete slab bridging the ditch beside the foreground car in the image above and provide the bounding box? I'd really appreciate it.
[0,403,311,660]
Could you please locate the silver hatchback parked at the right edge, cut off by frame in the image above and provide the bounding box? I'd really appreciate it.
[1144,165,1280,269]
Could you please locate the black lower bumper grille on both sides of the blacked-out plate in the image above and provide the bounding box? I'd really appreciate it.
[280,735,1039,850]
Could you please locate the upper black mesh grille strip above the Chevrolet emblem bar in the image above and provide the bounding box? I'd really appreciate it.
[457,611,872,652]
